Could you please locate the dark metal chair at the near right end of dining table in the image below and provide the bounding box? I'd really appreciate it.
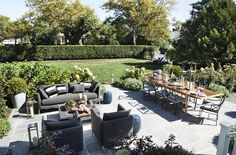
[199,94,226,125]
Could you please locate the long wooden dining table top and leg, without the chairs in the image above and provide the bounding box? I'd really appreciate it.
[148,76,223,114]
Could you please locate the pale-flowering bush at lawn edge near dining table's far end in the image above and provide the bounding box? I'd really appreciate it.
[121,66,146,80]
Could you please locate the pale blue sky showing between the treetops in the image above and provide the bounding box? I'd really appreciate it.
[0,0,198,21]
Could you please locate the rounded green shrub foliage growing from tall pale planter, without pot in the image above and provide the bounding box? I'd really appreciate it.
[6,77,28,95]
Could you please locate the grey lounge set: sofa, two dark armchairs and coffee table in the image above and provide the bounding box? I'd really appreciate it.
[33,81,133,152]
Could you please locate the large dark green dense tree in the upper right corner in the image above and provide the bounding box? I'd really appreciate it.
[176,0,236,64]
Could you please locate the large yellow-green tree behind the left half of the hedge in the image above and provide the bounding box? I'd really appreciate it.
[27,0,99,44]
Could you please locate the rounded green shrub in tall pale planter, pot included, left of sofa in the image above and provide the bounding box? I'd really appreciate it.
[6,77,28,109]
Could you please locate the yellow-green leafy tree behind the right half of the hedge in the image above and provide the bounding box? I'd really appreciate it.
[103,0,170,44]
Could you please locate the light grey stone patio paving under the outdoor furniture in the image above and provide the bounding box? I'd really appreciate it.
[0,85,236,155]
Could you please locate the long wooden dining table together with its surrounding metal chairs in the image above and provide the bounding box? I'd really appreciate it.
[143,76,226,124]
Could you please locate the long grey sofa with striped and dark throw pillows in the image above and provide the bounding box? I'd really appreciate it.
[37,80,99,112]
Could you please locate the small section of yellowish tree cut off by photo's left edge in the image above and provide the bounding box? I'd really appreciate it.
[0,15,10,42]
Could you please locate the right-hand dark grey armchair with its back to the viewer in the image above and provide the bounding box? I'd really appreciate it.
[91,105,133,148]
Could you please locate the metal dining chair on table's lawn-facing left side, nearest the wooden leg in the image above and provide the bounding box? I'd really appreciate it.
[166,91,185,114]
